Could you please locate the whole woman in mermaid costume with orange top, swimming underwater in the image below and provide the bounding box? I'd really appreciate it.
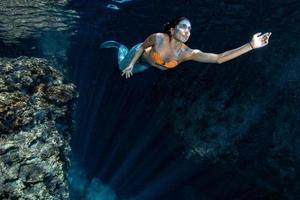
[100,17,272,78]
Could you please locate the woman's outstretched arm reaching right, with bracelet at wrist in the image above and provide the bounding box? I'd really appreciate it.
[187,32,272,64]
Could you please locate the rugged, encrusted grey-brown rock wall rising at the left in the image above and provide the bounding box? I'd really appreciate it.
[0,57,78,199]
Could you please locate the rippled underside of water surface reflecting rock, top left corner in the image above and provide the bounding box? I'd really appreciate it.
[0,0,79,43]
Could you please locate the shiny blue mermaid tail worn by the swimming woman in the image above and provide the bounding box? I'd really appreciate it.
[100,40,150,73]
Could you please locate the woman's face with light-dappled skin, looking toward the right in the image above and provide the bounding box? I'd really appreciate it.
[173,19,192,43]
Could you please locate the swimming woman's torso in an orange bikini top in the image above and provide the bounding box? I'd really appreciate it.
[142,34,187,70]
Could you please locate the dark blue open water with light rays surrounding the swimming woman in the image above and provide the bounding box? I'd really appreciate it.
[0,0,300,200]
